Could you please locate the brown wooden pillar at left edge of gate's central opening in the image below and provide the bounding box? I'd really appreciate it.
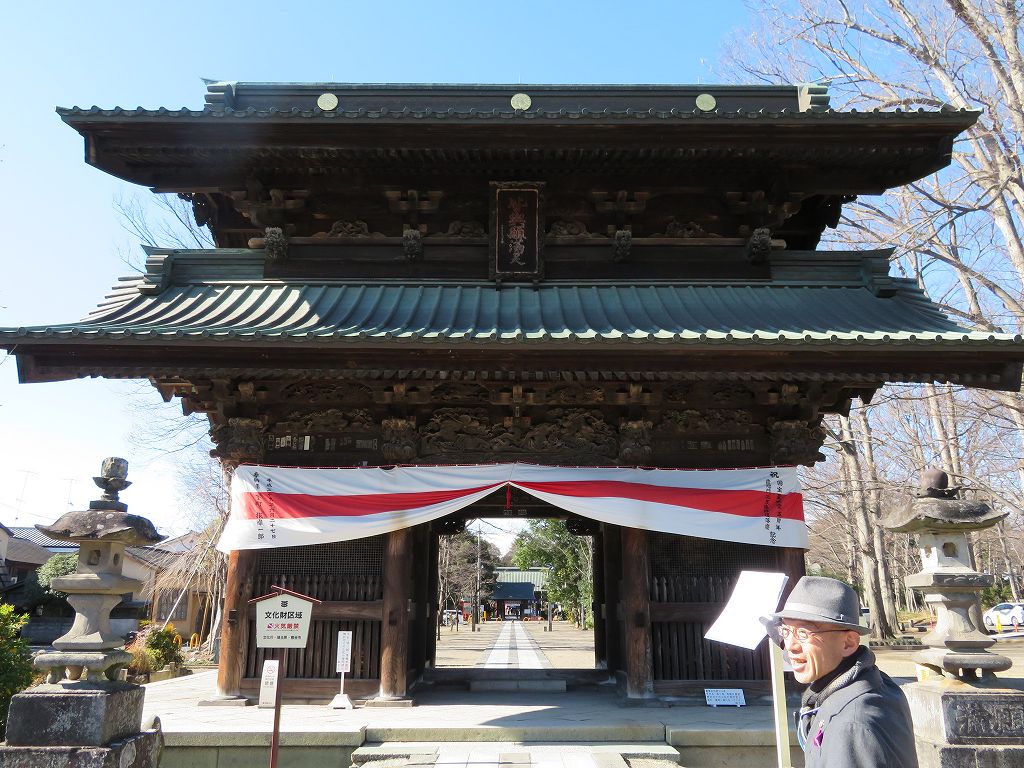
[377,528,413,700]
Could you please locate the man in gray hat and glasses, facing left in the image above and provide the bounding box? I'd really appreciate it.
[762,577,918,768]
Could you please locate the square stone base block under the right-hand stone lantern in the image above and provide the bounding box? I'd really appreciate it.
[903,679,1024,768]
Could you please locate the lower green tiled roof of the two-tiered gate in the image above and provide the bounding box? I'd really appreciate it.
[6,280,1021,348]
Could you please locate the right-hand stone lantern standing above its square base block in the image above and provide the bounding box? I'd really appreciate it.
[884,469,1013,678]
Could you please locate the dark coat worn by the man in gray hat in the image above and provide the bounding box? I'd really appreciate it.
[805,664,918,768]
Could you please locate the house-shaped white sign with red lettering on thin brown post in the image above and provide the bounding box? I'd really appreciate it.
[249,587,319,768]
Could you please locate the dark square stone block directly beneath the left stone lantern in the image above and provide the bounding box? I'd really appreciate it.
[7,682,145,749]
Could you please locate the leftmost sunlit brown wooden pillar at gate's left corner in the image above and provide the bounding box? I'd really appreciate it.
[214,549,257,702]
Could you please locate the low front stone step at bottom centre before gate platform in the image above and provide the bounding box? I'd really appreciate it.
[352,741,679,768]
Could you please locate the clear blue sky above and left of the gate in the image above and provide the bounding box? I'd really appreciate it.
[0,0,748,534]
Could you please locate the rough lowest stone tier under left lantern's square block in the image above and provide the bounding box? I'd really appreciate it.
[0,723,164,768]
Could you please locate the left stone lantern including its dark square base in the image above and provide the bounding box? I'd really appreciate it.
[0,458,164,768]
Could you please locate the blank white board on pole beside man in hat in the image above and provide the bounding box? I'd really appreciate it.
[705,570,793,768]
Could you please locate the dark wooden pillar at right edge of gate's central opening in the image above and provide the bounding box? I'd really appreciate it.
[623,528,654,698]
